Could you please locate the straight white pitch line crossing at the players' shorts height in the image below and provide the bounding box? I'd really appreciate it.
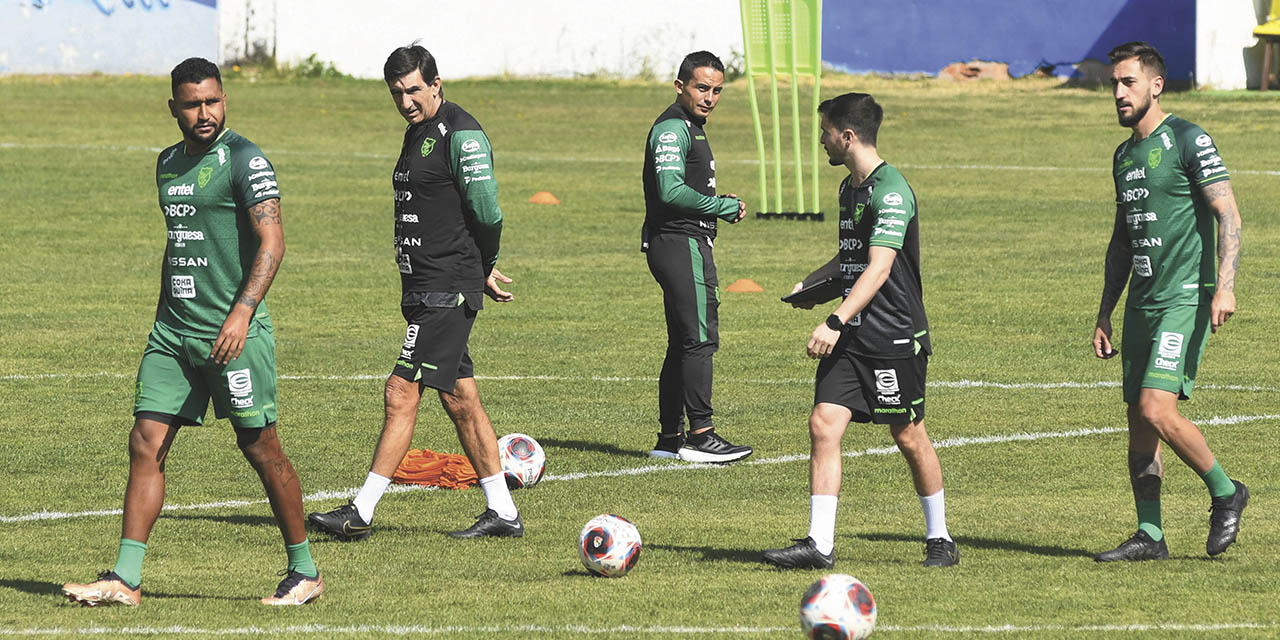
[0,371,1280,393]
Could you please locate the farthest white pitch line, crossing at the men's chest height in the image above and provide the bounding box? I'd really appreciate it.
[0,142,1280,175]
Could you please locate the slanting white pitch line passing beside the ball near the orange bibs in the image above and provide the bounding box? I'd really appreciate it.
[0,413,1280,522]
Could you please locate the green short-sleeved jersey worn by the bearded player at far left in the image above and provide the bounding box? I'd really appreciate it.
[156,129,280,339]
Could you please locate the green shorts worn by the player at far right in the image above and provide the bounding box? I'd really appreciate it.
[1120,305,1210,404]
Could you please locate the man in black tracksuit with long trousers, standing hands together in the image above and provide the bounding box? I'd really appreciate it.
[641,51,751,462]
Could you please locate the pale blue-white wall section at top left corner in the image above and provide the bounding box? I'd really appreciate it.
[0,0,219,74]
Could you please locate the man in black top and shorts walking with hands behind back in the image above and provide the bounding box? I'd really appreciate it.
[308,44,525,540]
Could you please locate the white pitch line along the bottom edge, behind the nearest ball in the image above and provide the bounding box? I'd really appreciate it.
[0,622,1280,636]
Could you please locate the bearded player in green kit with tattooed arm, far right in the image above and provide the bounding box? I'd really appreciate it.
[1093,42,1249,562]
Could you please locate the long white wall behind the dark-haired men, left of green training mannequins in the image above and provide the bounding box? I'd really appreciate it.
[219,0,742,78]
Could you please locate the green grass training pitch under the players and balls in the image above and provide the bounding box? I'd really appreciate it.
[0,72,1280,639]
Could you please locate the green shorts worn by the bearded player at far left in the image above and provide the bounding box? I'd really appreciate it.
[133,320,276,428]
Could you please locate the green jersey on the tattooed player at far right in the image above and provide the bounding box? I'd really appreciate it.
[1112,115,1229,308]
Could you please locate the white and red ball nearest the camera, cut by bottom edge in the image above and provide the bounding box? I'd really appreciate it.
[800,573,876,640]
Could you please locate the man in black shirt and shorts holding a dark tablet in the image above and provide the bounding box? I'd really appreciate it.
[763,93,960,568]
